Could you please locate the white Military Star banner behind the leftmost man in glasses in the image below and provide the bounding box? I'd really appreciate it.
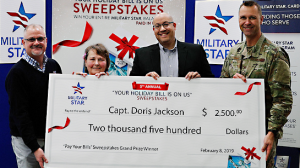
[0,0,45,64]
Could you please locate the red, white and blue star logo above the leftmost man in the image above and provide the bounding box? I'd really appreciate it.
[7,2,36,32]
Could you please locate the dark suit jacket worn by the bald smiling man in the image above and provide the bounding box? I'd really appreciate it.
[130,41,214,77]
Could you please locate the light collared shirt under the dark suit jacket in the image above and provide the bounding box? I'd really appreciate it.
[158,40,178,77]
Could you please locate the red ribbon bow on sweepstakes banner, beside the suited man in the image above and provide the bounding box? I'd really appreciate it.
[109,33,139,60]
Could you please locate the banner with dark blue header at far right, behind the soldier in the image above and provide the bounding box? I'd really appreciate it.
[258,0,300,148]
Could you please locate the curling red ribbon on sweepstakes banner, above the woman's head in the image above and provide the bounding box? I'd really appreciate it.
[53,22,93,54]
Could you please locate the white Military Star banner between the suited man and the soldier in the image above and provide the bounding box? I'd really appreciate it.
[194,0,242,64]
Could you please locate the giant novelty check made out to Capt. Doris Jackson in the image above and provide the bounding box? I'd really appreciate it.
[45,74,265,168]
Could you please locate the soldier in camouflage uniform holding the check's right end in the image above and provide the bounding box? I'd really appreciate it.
[220,1,293,168]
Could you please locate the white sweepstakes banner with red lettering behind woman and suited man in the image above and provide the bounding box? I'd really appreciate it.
[52,0,185,76]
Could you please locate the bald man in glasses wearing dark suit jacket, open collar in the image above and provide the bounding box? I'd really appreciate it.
[130,13,214,80]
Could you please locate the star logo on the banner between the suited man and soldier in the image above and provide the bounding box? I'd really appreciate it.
[204,5,233,35]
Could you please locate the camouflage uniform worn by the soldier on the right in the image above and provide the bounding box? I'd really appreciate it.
[220,34,293,168]
